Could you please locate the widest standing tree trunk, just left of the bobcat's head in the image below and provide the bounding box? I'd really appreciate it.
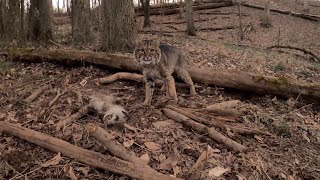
[101,0,135,51]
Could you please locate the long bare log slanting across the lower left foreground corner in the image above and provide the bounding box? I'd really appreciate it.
[0,121,177,180]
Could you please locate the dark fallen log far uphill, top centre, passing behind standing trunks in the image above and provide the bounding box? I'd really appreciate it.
[136,1,233,16]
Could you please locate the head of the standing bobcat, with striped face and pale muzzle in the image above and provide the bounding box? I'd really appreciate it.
[134,40,161,66]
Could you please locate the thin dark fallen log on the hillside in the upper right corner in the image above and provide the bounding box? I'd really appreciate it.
[242,3,320,22]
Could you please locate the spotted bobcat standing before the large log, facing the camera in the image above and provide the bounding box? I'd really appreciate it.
[134,40,196,105]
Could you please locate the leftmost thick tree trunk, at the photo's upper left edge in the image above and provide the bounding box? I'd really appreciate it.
[4,0,20,42]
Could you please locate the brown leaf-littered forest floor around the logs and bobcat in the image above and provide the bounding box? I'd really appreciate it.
[0,0,320,180]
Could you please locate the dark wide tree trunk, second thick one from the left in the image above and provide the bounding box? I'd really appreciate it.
[28,0,53,42]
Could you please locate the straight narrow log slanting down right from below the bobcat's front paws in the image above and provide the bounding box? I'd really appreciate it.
[163,108,247,152]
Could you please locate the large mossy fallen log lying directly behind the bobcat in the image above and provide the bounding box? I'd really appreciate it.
[0,49,320,98]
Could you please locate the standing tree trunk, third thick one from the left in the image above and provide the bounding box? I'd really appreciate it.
[71,0,91,43]
